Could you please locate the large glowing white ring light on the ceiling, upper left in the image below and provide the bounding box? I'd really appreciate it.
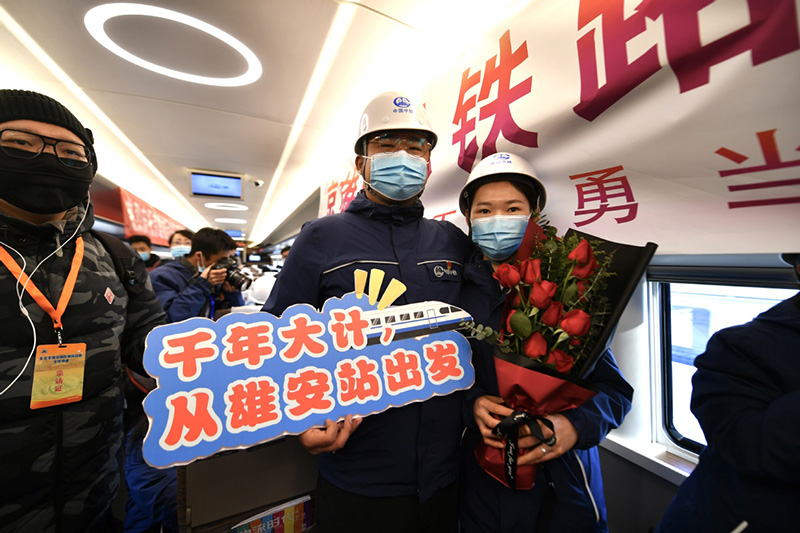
[83,3,262,87]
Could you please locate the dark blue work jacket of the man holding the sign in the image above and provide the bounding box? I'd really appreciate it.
[263,191,473,501]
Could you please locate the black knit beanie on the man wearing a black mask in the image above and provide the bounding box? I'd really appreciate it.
[0,89,97,172]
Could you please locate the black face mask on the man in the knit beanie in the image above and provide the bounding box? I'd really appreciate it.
[0,150,94,215]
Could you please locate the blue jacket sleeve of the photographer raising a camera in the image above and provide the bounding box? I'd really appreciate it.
[150,266,211,323]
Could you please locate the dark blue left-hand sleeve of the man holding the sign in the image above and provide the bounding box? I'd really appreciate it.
[261,224,325,316]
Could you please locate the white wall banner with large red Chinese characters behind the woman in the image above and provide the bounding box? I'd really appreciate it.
[320,0,800,254]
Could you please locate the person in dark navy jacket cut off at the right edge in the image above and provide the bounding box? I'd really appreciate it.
[656,254,800,533]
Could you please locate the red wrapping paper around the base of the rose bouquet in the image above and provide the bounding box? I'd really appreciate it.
[475,349,596,490]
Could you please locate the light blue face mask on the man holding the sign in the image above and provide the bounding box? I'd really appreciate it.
[369,150,428,201]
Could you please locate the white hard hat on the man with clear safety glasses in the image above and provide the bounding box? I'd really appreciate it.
[355,91,436,155]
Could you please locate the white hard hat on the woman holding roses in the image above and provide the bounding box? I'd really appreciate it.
[458,152,547,215]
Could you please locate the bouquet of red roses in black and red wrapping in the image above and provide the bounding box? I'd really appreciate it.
[464,221,657,489]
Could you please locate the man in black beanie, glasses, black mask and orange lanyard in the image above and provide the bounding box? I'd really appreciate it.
[0,89,164,533]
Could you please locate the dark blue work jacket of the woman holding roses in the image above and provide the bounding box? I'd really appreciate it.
[459,258,633,533]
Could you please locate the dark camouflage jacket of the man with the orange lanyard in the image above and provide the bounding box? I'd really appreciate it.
[0,202,164,532]
